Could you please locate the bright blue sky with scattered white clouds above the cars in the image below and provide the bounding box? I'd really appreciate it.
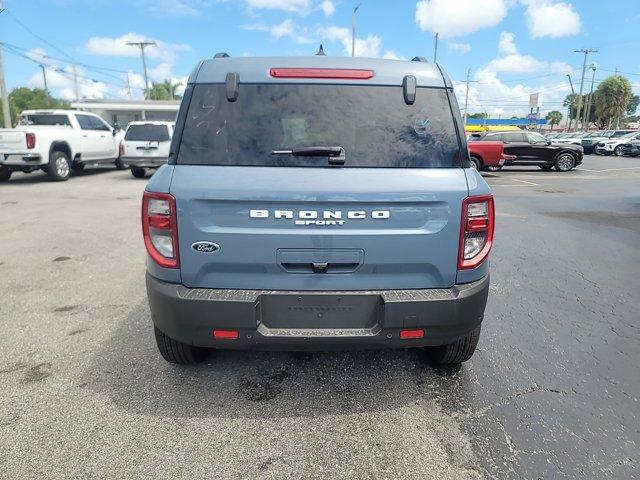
[0,0,640,115]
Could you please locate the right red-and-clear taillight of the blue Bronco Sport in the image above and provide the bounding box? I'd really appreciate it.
[458,195,495,270]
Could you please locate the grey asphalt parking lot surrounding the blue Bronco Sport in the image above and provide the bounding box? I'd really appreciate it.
[0,156,640,479]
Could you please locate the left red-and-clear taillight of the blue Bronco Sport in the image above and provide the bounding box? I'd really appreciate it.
[142,192,180,268]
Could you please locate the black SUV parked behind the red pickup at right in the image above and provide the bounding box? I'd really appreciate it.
[474,131,584,172]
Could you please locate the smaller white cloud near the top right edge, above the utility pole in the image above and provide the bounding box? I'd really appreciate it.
[523,0,580,38]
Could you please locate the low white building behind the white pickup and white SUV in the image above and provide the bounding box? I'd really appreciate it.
[71,100,180,128]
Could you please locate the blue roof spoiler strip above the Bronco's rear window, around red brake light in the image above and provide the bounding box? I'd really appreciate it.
[188,55,453,88]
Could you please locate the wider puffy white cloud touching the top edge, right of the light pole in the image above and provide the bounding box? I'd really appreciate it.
[415,0,508,38]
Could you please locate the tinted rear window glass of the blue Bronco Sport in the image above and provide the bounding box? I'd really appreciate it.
[177,84,460,167]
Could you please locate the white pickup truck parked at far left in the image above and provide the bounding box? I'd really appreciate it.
[0,110,124,181]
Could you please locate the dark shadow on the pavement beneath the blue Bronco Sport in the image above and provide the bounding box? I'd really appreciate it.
[78,303,468,418]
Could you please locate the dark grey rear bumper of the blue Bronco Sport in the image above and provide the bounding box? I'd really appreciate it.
[147,273,489,350]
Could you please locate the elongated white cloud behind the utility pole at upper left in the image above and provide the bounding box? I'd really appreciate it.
[85,32,191,63]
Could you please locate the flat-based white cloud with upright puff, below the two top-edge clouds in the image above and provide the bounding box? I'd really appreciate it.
[484,32,571,74]
